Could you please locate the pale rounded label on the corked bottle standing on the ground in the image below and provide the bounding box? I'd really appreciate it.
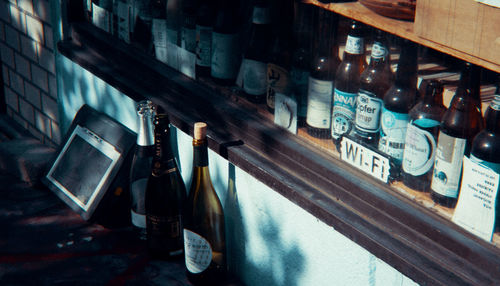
[184,229,212,273]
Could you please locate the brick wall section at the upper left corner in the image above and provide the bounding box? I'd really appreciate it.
[0,0,61,144]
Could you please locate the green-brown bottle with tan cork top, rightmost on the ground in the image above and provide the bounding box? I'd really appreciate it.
[184,122,226,285]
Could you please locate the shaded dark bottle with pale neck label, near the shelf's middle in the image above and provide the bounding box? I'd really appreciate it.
[242,0,272,103]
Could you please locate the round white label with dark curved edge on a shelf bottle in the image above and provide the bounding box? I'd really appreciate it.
[403,123,436,176]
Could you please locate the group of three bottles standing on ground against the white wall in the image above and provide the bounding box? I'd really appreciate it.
[130,101,226,285]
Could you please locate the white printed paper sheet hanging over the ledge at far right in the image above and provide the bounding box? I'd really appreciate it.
[452,156,499,241]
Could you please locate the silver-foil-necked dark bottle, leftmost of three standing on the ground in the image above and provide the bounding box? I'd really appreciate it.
[130,100,154,239]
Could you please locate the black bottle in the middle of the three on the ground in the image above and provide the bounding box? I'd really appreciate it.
[146,114,186,258]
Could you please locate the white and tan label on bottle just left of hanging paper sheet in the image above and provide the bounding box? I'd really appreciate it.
[431,132,467,198]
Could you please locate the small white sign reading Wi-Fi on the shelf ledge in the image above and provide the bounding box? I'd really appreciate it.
[340,136,390,183]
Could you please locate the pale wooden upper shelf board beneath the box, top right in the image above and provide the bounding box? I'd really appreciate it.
[304,0,500,73]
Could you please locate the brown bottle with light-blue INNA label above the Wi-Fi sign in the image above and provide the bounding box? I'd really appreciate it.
[331,20,366,146]
